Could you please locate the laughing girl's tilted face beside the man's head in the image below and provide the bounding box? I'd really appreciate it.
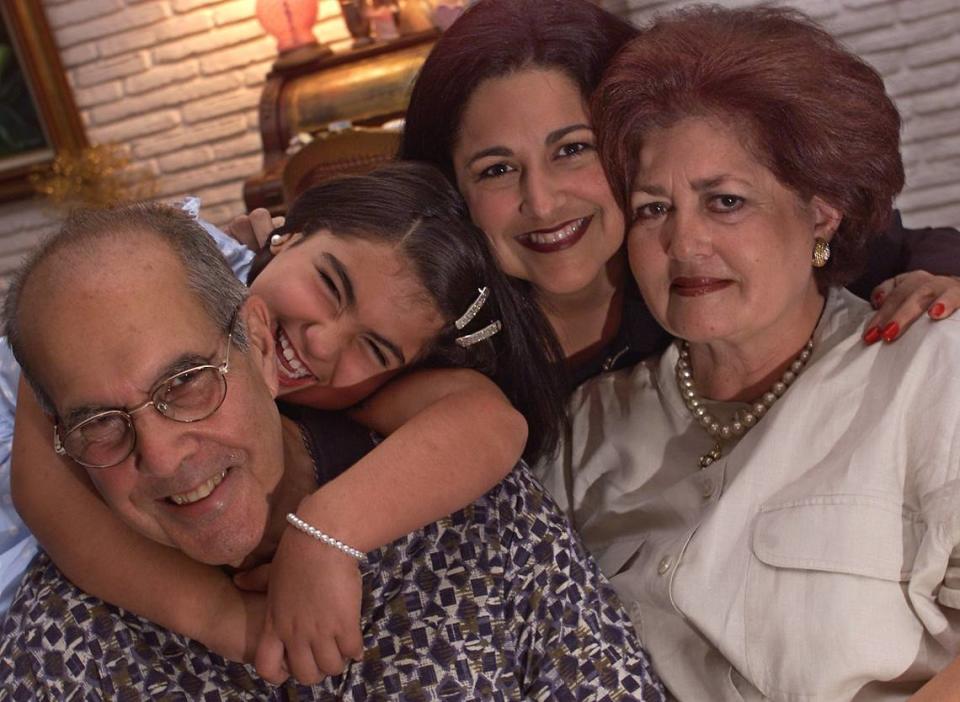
[250,231,443,409]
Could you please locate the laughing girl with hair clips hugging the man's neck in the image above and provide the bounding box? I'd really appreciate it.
[13,164,562,683]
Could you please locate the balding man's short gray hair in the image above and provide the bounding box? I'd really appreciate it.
[2,203,248,415]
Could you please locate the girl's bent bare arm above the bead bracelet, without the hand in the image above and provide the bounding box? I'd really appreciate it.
[308,368,527,551]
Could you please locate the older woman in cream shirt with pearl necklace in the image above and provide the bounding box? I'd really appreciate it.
[551,8,960,701]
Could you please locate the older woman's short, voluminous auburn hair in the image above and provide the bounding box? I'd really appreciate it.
[593,6,904,287]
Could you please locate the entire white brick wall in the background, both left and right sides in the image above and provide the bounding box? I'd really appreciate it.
[0,0,960,288]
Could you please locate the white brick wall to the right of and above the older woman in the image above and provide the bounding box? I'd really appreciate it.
[617,0,960,227]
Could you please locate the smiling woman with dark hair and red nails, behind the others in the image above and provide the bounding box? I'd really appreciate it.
[400,0,960,385]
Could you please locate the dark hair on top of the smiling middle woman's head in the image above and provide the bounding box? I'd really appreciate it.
[399,0,637,182]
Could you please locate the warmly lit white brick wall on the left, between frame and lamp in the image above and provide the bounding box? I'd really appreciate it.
[0,0,349,286]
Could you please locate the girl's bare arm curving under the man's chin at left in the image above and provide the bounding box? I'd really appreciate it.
[11,379,265,661]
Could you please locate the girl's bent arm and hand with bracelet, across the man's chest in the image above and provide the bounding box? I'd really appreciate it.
[248,369,526,683]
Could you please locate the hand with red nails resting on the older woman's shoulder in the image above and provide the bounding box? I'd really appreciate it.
[863,271,960,344]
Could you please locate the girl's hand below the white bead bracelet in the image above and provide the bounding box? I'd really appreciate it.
[246,527,363,685]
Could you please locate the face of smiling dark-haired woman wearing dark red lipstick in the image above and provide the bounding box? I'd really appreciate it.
[453,68,624,295]
